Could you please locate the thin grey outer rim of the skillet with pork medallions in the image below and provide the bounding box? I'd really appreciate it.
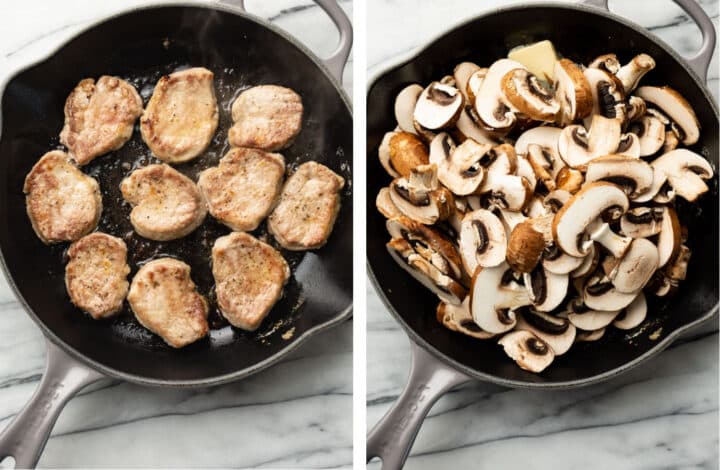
[0,1,354,388]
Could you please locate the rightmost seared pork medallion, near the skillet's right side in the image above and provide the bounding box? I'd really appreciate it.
[268,162,345,250]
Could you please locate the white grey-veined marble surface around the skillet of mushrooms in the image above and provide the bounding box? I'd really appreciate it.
[367,0,718,470]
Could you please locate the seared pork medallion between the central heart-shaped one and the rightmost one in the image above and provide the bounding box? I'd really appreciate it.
[198,148,285,232]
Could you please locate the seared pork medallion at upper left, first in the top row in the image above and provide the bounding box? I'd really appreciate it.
[60,76,143,165]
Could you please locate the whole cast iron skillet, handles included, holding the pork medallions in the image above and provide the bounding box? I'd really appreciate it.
[0,0,352,467]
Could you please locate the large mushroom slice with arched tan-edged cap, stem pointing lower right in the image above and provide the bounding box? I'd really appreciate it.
[553,181,629,258]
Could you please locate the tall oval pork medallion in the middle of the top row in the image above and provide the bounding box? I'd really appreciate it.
[140,67,219,163]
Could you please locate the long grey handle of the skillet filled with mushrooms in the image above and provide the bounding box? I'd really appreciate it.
[367,341,472,470]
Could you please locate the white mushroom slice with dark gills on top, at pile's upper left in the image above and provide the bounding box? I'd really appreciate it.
[413,82,463,130]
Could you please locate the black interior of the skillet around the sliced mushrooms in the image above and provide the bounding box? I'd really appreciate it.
[367,6,718,386]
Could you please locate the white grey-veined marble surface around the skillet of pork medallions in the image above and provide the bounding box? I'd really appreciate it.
[0,0,352,468]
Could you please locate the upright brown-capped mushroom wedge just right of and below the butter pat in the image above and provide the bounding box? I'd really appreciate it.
[554,59,593,126]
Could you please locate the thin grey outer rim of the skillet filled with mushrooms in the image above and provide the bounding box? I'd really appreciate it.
[365,2,720,390]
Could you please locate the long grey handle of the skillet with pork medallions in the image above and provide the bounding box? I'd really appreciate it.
[0,340,104,468]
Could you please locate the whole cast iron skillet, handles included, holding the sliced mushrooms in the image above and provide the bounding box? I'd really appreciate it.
[367,0,718,469]
